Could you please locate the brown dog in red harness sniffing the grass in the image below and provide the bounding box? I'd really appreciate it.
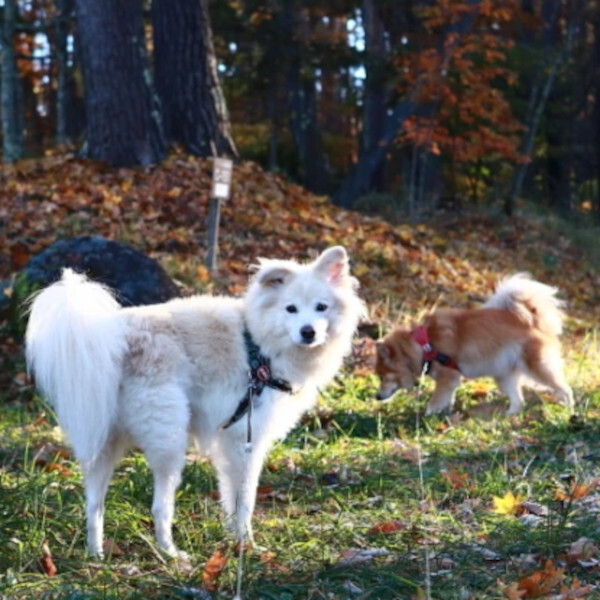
[375,273,573,414]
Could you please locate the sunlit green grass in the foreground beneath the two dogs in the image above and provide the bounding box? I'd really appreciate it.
[0,359,600,600]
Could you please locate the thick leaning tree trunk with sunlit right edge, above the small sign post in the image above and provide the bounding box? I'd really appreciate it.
[152,0,237,156]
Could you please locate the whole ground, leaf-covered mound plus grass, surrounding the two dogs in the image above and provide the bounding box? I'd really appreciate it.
[0,155,600,600]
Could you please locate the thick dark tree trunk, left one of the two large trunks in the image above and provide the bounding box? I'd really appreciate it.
[75,0,165,166]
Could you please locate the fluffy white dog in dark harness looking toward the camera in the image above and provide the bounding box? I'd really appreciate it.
[26,246,365,556]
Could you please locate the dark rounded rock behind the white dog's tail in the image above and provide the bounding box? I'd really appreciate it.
[11,236,181,333]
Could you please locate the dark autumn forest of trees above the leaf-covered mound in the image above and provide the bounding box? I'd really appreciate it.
[0,0,600,222]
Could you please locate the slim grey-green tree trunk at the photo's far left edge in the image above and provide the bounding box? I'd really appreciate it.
[0,0,23,163]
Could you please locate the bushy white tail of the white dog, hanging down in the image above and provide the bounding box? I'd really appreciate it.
[26,269,127,463]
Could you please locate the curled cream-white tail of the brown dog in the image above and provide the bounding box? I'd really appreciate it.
[484,273,564,335]
